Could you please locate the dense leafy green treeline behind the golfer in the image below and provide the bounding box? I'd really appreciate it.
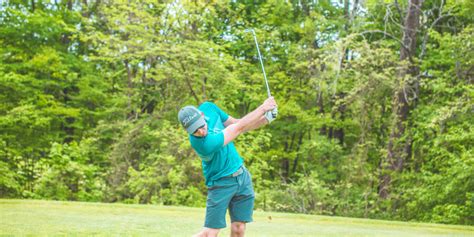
[0,0,474,225]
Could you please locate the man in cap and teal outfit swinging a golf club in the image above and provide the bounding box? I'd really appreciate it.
[178,97,277,237]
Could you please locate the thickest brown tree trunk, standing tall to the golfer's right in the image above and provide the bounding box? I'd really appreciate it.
[379,0,423,199]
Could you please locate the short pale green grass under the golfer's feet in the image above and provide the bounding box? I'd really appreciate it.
[0,199,474,237]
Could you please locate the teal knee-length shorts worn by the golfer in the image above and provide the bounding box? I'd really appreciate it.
[204,167,255,229]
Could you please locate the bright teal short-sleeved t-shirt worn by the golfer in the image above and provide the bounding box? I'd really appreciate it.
[189,102,243,187]
